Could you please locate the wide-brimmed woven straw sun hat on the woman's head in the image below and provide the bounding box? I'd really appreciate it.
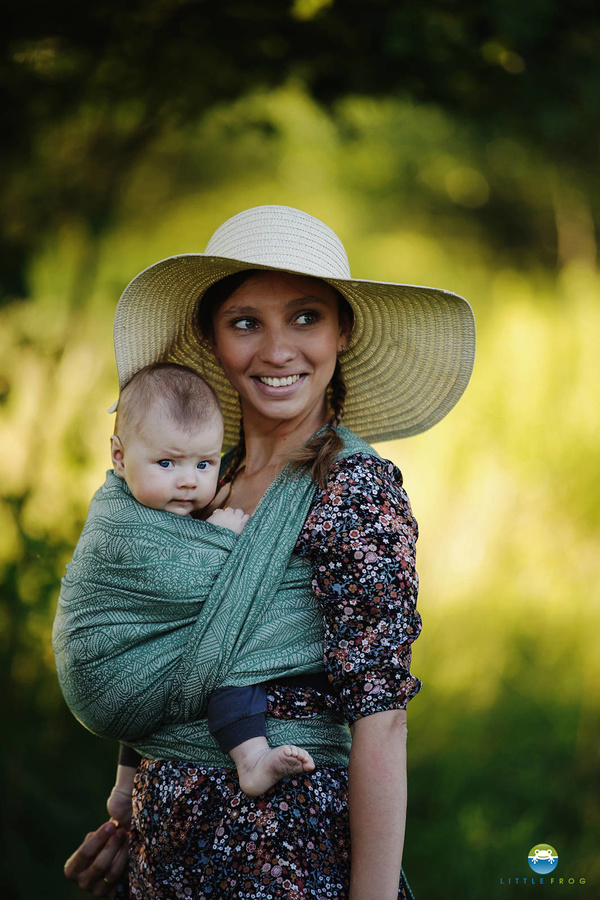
[114,206,475,448]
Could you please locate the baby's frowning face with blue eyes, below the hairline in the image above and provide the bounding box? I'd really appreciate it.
[113,407,223,516]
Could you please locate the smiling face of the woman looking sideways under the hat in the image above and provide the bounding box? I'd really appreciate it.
[213,272,350,424]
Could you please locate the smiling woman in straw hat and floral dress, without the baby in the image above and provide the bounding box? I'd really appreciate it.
[65,207,475,900]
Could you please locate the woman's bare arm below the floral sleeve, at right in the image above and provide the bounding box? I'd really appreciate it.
[349,710,406,900]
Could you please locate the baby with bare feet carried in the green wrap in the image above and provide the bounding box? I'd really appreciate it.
[108,363,314,821]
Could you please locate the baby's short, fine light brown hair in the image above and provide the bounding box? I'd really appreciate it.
[115,363,222,436]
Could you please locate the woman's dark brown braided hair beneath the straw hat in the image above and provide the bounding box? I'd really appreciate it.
[198,269,354,488]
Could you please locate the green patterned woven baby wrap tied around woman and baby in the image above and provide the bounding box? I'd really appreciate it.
[53,426,374,767]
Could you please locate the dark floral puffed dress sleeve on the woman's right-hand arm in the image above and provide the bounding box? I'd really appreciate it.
[296,453,421,722]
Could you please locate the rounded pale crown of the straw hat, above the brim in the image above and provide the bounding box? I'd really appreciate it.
[205,206,350,279]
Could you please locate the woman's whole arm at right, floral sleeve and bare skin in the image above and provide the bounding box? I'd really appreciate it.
[298,454,421,900]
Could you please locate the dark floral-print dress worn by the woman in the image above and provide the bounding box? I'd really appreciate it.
[129,453,421,900]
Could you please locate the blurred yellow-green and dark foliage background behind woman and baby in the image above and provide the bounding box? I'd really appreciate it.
[0,0,600,900]
